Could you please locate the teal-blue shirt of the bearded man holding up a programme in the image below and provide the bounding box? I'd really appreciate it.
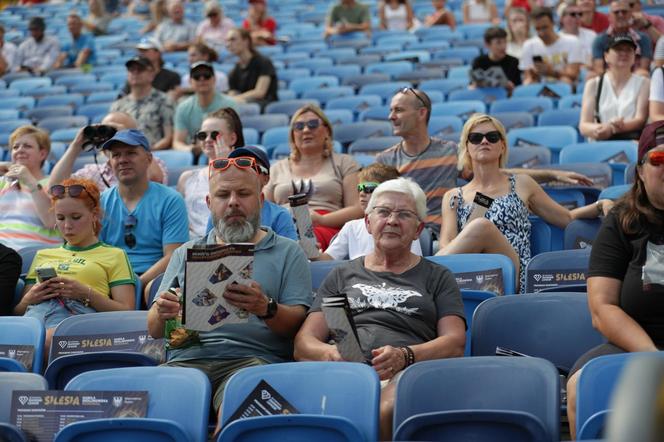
[155,228,312,362]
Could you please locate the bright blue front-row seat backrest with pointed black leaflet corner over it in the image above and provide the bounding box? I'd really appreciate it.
[221,362,380,441]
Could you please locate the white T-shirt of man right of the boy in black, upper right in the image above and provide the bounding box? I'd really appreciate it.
[519,34,584,71]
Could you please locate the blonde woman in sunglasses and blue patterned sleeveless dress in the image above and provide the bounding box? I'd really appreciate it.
[438,114,613,291]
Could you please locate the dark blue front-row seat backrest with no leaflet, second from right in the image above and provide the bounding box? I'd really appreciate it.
[393,358,560,441]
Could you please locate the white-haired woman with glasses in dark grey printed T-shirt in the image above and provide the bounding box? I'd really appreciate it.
[294,178,466,440]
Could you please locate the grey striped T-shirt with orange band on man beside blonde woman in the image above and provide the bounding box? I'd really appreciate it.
[376,138,459,235]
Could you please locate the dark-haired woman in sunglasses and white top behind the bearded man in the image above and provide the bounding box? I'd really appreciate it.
[177,108,244,238]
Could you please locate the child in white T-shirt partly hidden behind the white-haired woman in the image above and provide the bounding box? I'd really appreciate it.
[318,163,422,260]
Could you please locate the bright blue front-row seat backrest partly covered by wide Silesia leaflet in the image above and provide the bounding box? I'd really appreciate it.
[65,367,211,442]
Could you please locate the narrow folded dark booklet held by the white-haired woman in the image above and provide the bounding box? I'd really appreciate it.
[320,296,367,363]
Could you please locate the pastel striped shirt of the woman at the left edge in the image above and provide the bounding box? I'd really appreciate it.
[0,178,62,251]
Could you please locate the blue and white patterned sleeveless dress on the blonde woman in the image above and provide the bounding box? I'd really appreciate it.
[450,175,530,293]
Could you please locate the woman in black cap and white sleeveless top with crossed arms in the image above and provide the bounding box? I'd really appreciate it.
[579,34,650,140]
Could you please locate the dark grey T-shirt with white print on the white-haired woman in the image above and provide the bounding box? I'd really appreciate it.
[310,257,465,359]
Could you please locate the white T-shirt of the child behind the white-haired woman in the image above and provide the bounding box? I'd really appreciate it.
[325,218,422,259]
